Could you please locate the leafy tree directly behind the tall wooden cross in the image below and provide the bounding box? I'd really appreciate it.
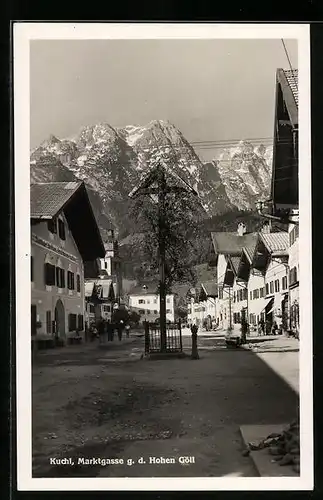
[131,145,205,293]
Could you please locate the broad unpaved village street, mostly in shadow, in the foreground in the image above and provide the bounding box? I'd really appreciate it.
[32,332,298,477]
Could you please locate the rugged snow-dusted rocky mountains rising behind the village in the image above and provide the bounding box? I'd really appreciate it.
[30,120,272,239]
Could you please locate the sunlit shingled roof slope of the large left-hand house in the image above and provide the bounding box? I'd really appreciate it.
[30,182,82,219]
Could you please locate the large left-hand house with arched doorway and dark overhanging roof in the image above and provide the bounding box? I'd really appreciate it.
[31,182,104,344]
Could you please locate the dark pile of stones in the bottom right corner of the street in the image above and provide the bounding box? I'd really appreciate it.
[248,421,300,474]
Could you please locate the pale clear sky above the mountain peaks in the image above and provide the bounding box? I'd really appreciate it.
[30,39,297,160]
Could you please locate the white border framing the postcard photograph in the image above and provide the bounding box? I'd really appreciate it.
[13,23,313,491]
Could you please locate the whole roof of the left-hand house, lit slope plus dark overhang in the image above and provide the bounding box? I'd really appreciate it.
[30,182,105,262]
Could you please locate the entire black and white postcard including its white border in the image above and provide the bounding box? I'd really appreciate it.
[14,22,313,491]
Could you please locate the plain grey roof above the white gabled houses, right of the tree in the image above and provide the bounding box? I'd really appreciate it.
[211,232,257,256]
